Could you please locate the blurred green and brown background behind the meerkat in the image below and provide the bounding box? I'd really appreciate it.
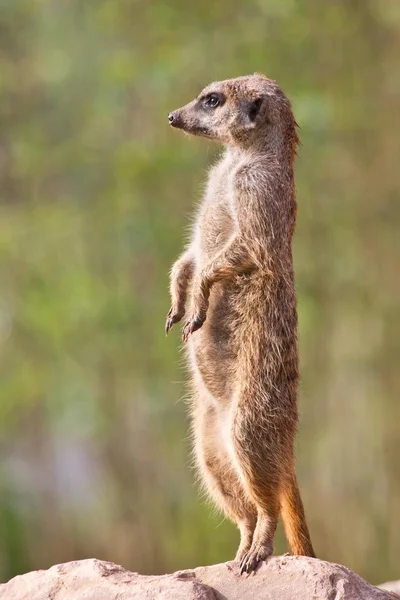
[0,0,400,583]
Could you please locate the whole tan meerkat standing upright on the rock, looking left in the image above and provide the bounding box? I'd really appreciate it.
[166,73,315,573]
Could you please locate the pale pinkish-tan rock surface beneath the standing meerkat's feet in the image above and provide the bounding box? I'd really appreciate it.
[0,556,400,600]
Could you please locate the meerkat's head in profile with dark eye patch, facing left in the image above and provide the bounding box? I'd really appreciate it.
[168,73,297,147]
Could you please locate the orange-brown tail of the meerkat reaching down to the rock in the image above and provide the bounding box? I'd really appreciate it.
[280,476,315,557]
